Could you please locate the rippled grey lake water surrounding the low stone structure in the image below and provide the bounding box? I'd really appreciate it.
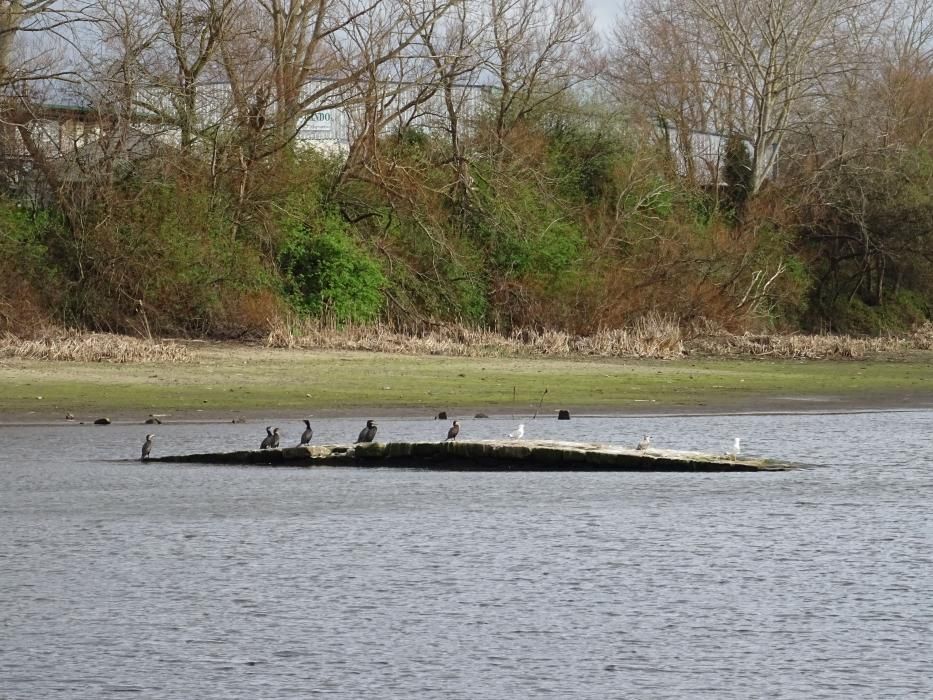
[0,411,933,700]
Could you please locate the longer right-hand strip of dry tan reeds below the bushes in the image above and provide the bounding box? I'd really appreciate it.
[266,314,933,359]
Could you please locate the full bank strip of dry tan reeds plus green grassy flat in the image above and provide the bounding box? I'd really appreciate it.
[0,319,933,422]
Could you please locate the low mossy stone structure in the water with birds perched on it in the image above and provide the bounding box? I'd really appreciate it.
[149,440,796,472]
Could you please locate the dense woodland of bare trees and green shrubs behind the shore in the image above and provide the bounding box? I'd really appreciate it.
[0,0,933,337]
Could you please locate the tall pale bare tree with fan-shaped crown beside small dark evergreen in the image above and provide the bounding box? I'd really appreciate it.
[616,0,877,193]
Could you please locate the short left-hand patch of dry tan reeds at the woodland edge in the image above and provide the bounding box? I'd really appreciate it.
[0,330,192,363]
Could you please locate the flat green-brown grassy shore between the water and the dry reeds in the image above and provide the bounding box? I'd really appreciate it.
[0,344,933,423]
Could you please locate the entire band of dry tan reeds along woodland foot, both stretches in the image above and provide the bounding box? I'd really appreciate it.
[0,315,933,363]
